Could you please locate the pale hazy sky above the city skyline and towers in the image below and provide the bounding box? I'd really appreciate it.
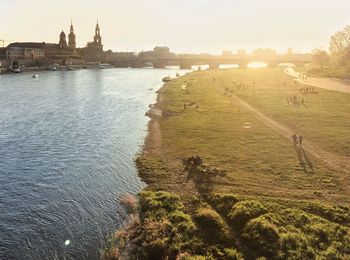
[0,0,350,53]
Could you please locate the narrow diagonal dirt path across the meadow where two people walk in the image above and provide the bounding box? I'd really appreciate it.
[232,95,350,176]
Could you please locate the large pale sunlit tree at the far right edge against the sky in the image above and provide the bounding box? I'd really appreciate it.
[329,26,350,66]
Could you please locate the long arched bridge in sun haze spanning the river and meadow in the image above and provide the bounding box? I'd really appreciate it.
[108,54,312,69]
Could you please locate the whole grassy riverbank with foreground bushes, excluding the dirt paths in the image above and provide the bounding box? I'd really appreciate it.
[102,69,350,260]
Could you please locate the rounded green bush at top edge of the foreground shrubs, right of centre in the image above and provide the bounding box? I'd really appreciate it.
[228,200,267,229]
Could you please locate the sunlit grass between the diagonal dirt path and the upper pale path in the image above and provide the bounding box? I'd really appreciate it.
[212,69,350,156]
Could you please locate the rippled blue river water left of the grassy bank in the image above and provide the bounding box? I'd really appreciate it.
[0,69,184,259]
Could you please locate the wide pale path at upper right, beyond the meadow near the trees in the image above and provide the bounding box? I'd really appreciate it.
[284,68,350,93]
